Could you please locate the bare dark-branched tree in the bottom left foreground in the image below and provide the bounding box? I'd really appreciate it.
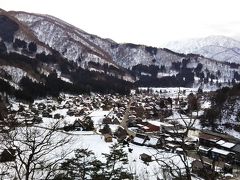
[3,123,71,180]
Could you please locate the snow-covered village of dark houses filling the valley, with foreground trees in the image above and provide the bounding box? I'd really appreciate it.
[0,87,240,179]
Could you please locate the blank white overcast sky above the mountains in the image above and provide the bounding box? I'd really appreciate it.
[0,0,240,47]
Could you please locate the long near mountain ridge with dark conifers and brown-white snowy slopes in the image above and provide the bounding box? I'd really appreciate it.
[0,10,240,100]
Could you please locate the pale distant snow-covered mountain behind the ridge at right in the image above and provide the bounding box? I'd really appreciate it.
[166,36,240,63]
